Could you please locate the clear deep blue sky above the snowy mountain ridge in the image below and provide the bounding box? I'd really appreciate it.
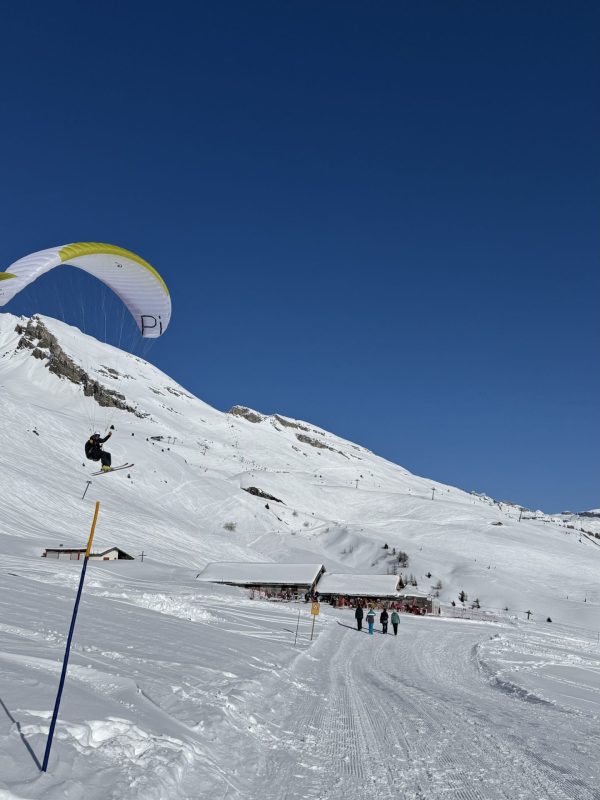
[0,0,600,510]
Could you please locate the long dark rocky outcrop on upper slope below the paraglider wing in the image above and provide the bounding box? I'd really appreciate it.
[15,317,149,418]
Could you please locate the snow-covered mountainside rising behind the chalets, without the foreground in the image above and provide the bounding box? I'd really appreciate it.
[0,315,600,626]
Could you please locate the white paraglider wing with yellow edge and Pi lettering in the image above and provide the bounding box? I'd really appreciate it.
[0,242,171,339]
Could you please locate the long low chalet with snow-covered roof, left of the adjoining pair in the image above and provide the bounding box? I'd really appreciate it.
[196,561,325,597]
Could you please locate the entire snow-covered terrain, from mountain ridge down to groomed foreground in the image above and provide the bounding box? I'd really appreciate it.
[0,314,600,800]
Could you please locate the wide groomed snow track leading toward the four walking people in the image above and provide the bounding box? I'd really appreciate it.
[251,620,600,800]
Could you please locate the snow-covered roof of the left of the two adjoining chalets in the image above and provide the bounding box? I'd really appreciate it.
[197,561,324,586]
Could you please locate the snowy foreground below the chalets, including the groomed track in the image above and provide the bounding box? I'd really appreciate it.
[0,580,600,800]
